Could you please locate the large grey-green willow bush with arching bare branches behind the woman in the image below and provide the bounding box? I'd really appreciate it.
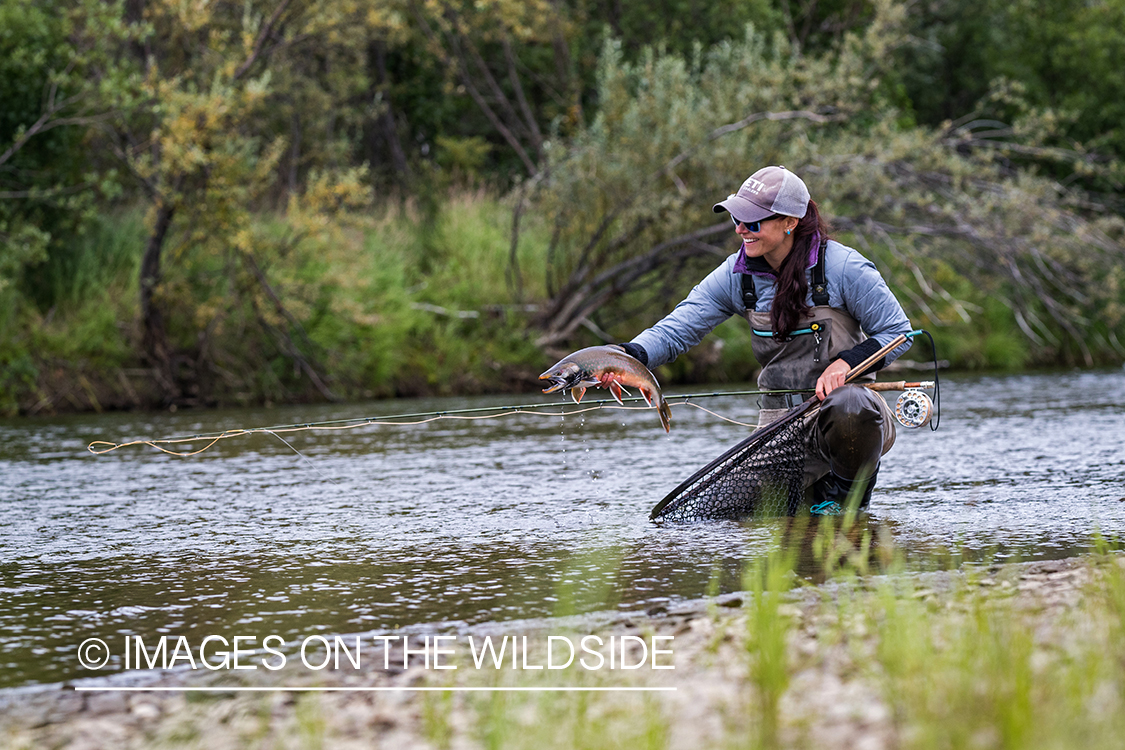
[530,3,1125,365]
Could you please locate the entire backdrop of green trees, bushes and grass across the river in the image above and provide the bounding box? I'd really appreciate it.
[0,0,1125,409]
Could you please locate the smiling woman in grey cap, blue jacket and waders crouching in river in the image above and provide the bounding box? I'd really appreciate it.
[562,166,910,512]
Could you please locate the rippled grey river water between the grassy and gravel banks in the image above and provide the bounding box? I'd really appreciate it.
[0,370,1125,687]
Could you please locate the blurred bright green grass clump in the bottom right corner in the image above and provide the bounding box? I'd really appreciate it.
[870,566,1121,748]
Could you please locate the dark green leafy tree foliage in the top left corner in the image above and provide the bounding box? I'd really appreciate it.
[0,0,135,299]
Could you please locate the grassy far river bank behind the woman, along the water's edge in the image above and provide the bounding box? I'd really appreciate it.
[0,190,1125,416]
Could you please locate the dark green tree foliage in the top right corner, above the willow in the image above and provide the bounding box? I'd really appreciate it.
[892,0,1125,172]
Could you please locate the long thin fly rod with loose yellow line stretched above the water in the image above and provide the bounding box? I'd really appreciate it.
[87,380,934,458]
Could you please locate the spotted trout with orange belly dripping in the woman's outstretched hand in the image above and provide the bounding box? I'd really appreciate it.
[539,346,672,432]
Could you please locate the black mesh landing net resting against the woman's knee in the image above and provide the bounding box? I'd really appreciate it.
[649,405,815,523]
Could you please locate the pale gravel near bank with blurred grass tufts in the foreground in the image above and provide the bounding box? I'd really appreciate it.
[0,555,1125,750]
